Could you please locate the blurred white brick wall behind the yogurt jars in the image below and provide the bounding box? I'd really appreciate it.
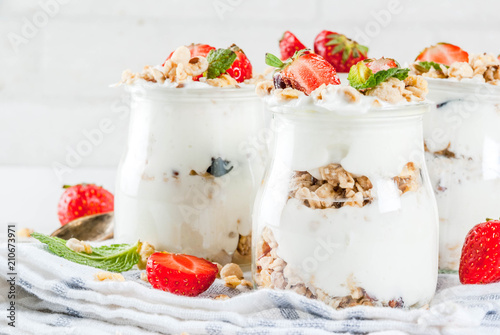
[0,0,500,234]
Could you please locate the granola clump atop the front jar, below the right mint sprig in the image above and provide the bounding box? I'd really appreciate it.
[365,75,429,103]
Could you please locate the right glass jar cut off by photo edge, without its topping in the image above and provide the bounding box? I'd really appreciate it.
[424,79,500,270]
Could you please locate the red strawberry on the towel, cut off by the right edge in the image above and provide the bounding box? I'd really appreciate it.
[458,220,500,284]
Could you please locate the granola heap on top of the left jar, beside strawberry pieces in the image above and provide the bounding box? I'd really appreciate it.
[120,46,238,87]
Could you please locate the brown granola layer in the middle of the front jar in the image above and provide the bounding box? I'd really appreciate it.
[290,164,373,209]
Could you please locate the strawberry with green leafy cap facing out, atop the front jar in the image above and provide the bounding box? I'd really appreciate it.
[314,30,368,72]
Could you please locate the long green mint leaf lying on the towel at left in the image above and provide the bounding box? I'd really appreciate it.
[31,233,140,272]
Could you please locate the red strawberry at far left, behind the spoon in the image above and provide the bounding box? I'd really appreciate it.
[57,184,114,225]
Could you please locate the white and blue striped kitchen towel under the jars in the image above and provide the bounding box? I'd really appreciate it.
[0,243,500,335]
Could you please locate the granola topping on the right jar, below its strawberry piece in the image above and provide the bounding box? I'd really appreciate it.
[410,53,500,85]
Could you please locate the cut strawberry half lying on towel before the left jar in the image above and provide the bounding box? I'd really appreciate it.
[146,252,219,297]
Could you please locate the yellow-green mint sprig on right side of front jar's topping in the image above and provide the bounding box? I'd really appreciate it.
[347,61,410,90]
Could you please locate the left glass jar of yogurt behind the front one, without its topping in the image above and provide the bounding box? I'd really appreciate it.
[115,86,266,264]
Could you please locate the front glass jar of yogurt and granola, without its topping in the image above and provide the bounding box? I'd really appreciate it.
[252,103,438,308]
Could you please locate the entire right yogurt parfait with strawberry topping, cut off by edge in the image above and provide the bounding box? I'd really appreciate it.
[411,43,500,270]
